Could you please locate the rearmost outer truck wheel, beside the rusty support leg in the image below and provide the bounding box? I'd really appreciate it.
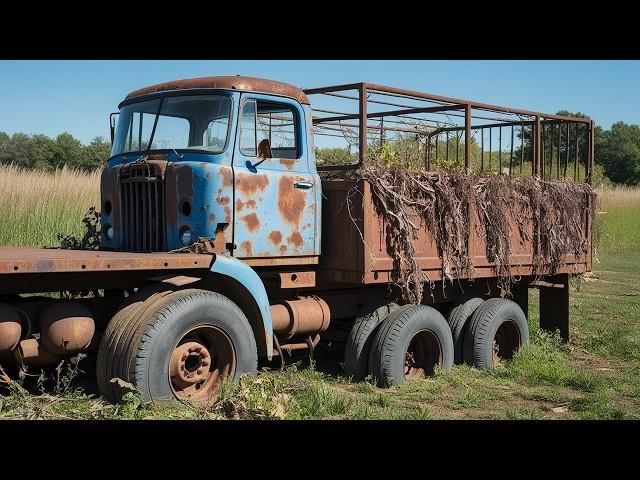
[463,298,529,369]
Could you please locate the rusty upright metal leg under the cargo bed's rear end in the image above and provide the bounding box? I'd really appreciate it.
[540,274,569,342]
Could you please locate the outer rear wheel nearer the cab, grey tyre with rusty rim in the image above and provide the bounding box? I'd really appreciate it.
[369,305,453,387]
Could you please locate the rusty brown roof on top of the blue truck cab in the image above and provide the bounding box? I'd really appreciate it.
[127,75,309,105]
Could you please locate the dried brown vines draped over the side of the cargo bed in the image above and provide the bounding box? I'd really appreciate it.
[344,164,596,303]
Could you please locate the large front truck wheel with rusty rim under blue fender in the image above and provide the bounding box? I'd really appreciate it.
[99,289,258,404]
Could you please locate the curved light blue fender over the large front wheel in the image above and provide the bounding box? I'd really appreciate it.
[211,255,273,360]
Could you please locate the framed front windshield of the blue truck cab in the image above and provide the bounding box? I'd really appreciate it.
[111,95,231,156]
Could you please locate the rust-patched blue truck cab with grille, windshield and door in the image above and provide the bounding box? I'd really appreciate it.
[101,76,321,266]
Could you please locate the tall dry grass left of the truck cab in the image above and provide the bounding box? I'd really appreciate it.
[0,165,100,247]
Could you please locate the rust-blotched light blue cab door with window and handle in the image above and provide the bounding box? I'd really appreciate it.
[233,94,320,258]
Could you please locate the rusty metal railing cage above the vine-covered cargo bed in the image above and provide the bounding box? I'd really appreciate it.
[304,82,594,183]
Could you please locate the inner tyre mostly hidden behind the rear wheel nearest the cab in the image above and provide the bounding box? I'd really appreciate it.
[344,302,399,382]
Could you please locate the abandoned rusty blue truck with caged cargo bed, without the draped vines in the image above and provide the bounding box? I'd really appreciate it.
[0,76,594,402]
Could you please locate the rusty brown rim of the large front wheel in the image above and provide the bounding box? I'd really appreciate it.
[169,325,236,403]
